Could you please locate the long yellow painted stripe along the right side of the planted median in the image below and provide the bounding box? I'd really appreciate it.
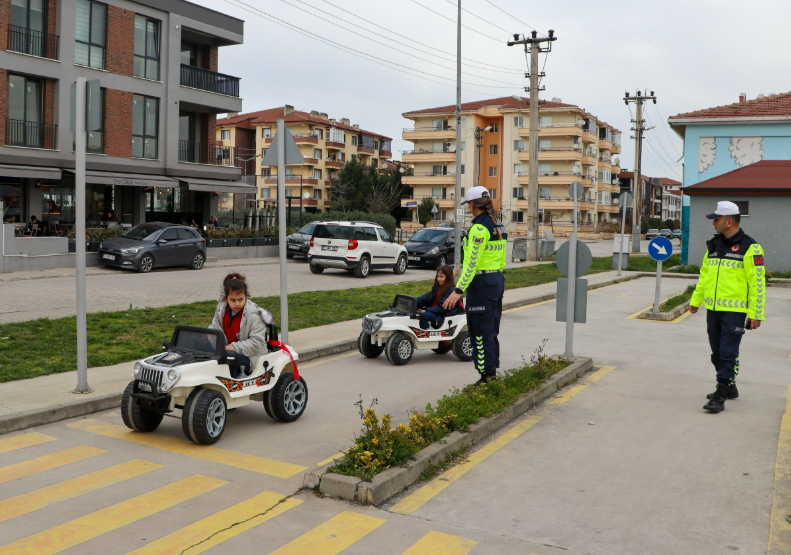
[390,366,615,515]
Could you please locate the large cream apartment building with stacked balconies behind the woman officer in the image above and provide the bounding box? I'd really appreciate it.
[402,97,621,234]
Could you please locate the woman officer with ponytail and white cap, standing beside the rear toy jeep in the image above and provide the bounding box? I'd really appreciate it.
[443,187,508,386]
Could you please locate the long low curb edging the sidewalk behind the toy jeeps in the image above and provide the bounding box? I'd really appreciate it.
[0,272,632,434]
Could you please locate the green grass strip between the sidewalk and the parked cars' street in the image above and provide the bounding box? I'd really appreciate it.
[0,257,611,382]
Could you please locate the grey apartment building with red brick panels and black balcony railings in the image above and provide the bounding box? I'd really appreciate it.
[0,0,254,225]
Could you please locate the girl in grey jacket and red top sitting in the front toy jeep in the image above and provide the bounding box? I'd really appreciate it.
[209,274,272,379]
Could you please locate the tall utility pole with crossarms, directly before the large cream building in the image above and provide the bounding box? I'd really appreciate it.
[508,29,557,260]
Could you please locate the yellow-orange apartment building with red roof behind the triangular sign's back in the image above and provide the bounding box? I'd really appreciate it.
[217,105,393,212]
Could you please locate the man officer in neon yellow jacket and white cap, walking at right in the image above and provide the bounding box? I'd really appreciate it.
[689,201,766,413]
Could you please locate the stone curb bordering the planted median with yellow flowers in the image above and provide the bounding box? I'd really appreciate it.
[312,357,593,506]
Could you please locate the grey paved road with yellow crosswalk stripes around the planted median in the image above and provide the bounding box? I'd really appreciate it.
[0,279,791,555]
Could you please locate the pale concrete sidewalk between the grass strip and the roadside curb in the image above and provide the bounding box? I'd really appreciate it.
[0,271,639,433]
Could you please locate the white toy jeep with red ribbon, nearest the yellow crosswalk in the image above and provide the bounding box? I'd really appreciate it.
[121,324,308,444]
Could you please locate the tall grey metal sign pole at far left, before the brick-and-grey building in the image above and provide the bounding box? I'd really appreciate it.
[74,77,91,393]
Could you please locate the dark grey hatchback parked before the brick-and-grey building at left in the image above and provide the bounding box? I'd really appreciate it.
[99,222,206,273]
